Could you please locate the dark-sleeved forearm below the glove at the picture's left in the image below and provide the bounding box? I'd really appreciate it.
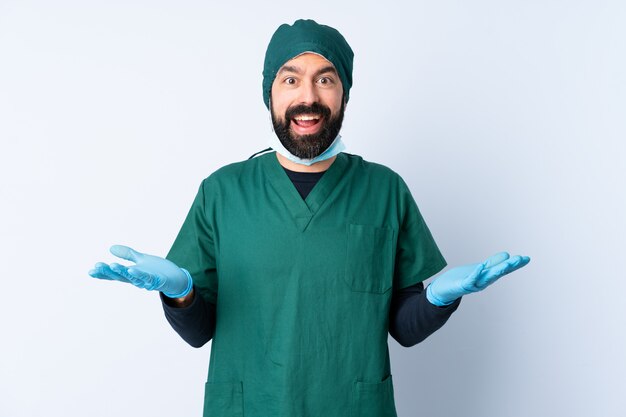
[161,289,216,347]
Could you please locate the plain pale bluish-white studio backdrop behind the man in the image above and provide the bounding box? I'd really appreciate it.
[0,0,626,417]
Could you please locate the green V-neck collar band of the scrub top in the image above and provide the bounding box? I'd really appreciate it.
[262,152,348,232]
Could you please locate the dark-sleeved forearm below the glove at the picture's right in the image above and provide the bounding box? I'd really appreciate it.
[389,283,461,347]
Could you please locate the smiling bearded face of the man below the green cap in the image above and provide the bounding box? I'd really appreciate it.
[270,53,345,159]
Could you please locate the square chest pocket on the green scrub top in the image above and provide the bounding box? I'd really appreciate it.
[344,224,394,294]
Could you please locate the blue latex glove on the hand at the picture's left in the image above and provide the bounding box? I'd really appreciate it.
[89,245,193,298]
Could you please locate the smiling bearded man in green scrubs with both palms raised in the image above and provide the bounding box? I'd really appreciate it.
[90,20,529,417]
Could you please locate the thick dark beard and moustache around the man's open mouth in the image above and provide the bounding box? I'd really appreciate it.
[270,100,345,159]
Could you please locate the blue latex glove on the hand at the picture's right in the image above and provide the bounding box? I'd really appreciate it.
[426,252,530,307]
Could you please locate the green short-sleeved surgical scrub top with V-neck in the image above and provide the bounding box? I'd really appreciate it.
[168,152,446,417]
